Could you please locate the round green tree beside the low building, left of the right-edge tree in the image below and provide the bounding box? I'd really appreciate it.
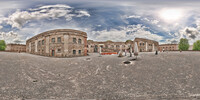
[178,38,190,51]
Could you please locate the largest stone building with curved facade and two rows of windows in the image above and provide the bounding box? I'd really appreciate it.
[26,29,87,57]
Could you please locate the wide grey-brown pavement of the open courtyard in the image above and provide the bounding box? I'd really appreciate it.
[0,52,200,100]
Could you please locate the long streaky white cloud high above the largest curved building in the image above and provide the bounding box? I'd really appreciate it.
[4,4,90,28]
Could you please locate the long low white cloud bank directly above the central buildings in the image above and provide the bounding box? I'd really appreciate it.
[92,24,163,41]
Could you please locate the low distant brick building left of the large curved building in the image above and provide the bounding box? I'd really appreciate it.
[6,44,26,52]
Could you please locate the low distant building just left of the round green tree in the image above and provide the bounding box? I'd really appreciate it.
[159,44,178,52]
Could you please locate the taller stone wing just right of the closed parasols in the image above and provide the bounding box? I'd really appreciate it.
[134,38,159,52]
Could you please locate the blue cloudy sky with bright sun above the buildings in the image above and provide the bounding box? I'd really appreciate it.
[0,0,200,44]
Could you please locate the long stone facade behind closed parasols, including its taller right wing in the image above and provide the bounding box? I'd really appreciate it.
[87,38,159,53]
